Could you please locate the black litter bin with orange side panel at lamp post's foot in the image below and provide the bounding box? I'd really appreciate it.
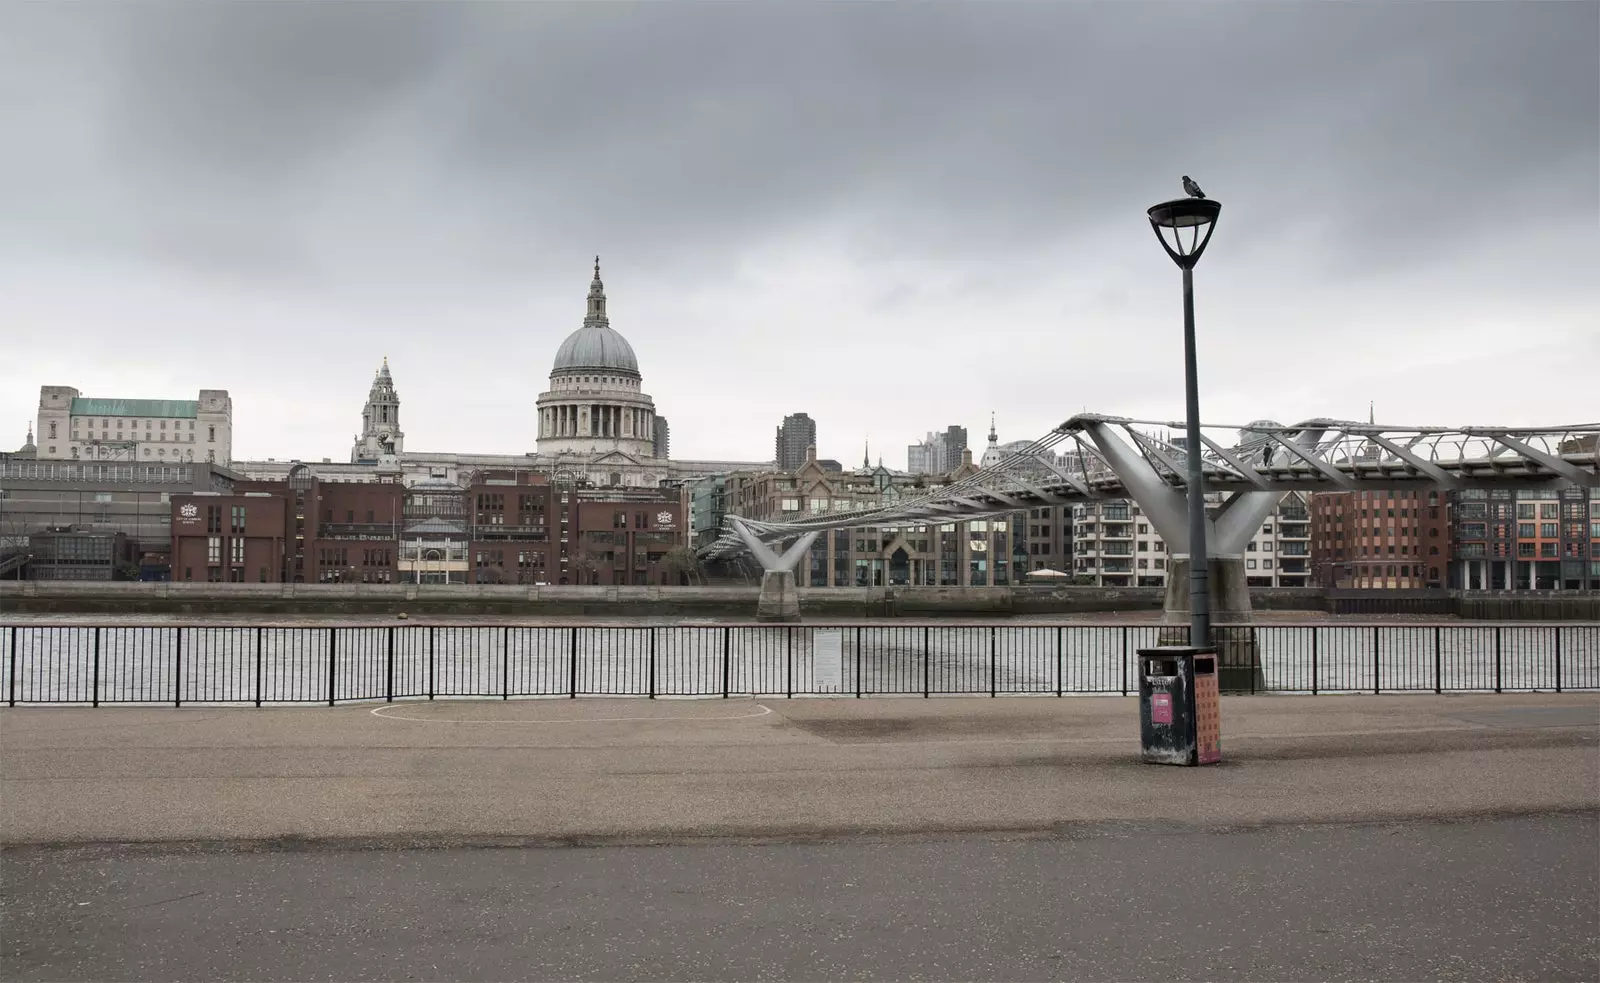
[1139,645,1222,765]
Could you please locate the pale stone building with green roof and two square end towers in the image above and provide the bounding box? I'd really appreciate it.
[37,386,234,464]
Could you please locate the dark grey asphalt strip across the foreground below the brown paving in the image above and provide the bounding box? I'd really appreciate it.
[0,812,1600,981]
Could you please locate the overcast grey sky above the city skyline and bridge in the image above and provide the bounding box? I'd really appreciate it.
[0,2,1600,466]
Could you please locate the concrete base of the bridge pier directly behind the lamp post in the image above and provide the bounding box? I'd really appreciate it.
[1158,554,1267,693]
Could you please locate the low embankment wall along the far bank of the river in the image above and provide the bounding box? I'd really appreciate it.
[0,581,1600,621]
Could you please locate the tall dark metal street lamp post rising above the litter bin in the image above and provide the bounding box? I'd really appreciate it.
[1149,185,1222,645]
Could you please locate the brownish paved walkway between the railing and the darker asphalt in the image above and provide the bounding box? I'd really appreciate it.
[0,693,1600,845]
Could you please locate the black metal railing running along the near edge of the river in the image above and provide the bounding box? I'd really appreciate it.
[0,623,1600,706]
